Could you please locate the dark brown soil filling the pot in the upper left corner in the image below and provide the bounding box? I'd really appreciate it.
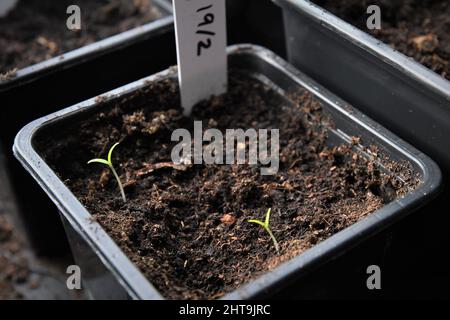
[0,0,161,77]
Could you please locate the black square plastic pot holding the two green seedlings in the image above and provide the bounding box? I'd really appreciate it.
[14,45,441,299]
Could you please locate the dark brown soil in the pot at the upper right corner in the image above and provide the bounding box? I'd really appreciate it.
[313,0,450,80]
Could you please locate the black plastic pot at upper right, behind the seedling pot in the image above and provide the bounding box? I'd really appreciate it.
[273,0,450,171]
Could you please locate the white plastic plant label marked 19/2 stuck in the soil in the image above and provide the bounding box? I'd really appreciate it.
[173,0,227,115]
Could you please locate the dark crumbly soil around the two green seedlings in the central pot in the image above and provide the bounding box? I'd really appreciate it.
[35,72,417,299]
